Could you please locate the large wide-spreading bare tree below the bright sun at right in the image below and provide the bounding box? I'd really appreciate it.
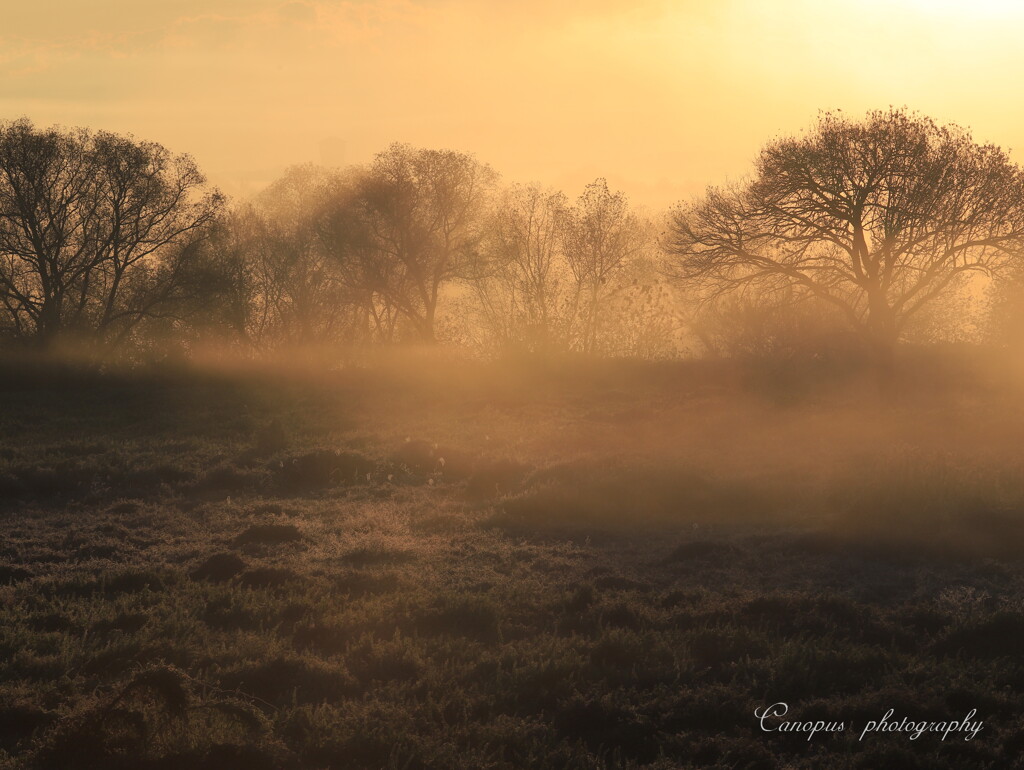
[666,110,1024,368]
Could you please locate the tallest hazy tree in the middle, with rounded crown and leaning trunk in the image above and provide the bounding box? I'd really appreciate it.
[358,144,497,342]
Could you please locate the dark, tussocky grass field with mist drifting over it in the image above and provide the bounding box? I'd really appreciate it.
[0,361,1024,770]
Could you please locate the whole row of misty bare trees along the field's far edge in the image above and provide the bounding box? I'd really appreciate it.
[6,109,1024,366]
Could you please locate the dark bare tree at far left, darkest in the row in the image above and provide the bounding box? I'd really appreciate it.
[0,120,222,345]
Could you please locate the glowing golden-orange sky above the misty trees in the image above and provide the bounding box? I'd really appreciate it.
[6,0,1024,210]
